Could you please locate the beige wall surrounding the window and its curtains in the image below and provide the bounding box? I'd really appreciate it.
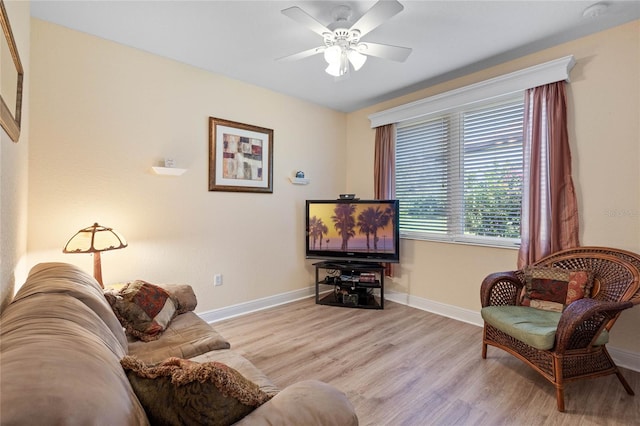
[347,21,640,354]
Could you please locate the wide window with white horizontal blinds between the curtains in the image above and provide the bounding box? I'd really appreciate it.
[396,95,524,246]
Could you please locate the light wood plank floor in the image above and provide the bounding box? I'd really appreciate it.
[214,299,640,426]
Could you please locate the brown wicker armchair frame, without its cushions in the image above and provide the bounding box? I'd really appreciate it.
[481,247,640,411]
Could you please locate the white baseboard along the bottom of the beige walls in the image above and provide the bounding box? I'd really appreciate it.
[198,286,640,372]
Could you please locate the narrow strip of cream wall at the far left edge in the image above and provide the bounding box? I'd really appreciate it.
[0,1,31,311]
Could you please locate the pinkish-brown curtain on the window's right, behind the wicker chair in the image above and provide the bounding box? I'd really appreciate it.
[518,81,580,268]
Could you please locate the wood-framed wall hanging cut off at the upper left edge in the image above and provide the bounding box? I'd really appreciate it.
[0,0,24,142]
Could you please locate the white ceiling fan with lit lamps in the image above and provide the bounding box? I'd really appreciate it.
[278,0,411,77]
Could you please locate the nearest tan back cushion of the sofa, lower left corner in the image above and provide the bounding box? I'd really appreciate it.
[0,291,148,426]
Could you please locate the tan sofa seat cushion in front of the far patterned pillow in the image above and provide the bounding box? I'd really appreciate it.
[129,312,230,363]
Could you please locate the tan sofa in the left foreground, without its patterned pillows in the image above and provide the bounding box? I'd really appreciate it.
[0,263,358,426]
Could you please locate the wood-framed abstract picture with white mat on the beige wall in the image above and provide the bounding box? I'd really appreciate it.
[209,117,273,193]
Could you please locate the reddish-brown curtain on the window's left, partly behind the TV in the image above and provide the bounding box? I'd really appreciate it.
[373,124,396,277]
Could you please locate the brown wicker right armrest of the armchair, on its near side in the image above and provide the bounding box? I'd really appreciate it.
[556,298,633,353]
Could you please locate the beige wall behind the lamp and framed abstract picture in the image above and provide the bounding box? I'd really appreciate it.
[28,19,346,312]
